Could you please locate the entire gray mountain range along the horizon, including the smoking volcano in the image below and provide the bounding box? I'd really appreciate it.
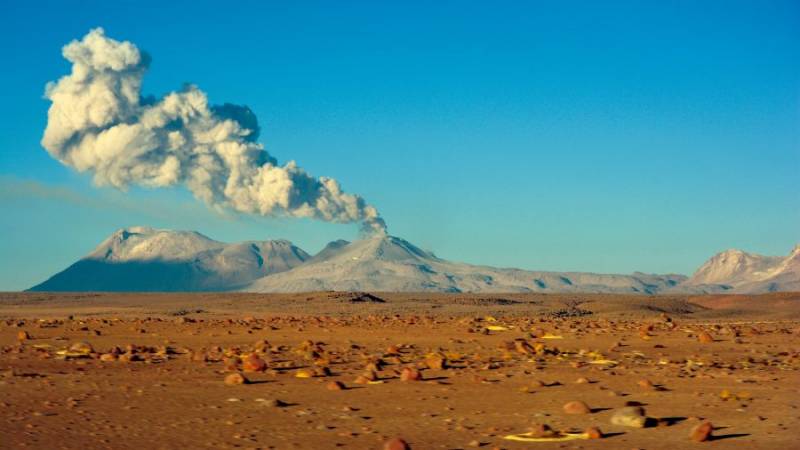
[30,227,800,294]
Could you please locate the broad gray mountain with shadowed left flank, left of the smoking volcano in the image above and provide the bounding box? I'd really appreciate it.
[30,227,310,292]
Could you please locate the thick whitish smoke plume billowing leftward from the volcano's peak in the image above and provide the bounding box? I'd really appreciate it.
[42,28,385,232]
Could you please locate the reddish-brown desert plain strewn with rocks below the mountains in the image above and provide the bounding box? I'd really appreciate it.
[0,292,800,450]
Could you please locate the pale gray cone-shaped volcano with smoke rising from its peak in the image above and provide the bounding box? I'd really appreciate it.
[244,236,686,294]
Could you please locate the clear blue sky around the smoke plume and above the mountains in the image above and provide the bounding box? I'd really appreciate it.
[0,0,800,290]
